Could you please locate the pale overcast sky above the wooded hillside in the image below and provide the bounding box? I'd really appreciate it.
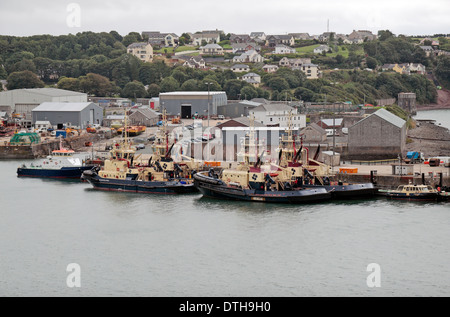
[0,0,450,36]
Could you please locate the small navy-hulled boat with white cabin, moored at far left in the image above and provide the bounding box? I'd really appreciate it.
[17,138,94,179]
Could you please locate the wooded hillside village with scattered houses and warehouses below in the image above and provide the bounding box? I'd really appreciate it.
[0,30,450,160]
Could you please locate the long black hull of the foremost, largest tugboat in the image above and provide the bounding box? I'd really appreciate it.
[194,173,331,204]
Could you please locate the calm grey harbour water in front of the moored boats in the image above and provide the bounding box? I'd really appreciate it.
[0,161,450,297]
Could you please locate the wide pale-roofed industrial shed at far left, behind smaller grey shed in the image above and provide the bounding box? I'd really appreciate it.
[0,88,87,121]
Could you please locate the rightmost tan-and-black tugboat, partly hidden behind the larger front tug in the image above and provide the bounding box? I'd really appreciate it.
[278,115,378,199]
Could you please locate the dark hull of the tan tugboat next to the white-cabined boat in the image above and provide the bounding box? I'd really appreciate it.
[81,170,197,195]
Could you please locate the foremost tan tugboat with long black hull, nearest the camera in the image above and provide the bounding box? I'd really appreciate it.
[194,115,331,204]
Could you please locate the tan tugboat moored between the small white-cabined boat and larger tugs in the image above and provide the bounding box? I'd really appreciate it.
[81,112,197,194]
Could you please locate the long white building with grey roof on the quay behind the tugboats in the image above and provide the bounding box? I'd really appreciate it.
[249,103,306,130]
